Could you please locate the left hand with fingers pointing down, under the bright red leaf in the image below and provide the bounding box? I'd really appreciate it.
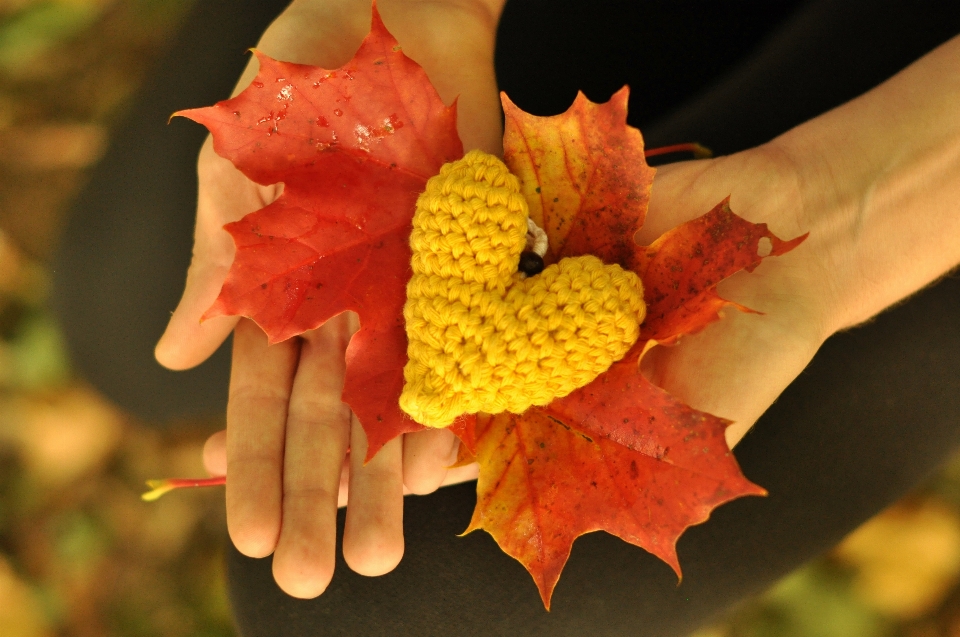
[156,0,503,598]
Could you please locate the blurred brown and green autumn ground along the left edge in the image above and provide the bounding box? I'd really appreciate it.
[0,0,234,637]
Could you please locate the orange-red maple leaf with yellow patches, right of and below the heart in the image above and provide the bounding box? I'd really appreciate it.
[458,88,805,609]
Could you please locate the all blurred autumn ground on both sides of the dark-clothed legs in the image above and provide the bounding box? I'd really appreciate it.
[0,0,960,637]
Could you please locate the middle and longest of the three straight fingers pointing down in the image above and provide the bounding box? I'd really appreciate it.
[273,315,353,598]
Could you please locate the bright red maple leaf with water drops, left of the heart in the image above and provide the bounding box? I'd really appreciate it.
[177,9,463,459]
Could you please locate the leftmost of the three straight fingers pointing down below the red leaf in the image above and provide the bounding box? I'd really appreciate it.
[227,319,300,557]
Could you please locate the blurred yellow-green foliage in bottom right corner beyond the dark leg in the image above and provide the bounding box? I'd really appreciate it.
[691,462,960,637]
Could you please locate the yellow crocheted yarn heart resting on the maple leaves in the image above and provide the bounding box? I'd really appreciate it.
[400,150,646,427]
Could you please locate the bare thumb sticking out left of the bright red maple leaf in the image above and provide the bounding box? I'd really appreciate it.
[154,137,277,369]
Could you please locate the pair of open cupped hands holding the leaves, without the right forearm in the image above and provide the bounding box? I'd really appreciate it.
[156,0,837,598]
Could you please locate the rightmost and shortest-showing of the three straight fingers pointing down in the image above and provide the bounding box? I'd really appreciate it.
[343,417,403,575]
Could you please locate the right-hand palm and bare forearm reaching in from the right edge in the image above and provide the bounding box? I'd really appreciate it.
[639,37,960,446]
